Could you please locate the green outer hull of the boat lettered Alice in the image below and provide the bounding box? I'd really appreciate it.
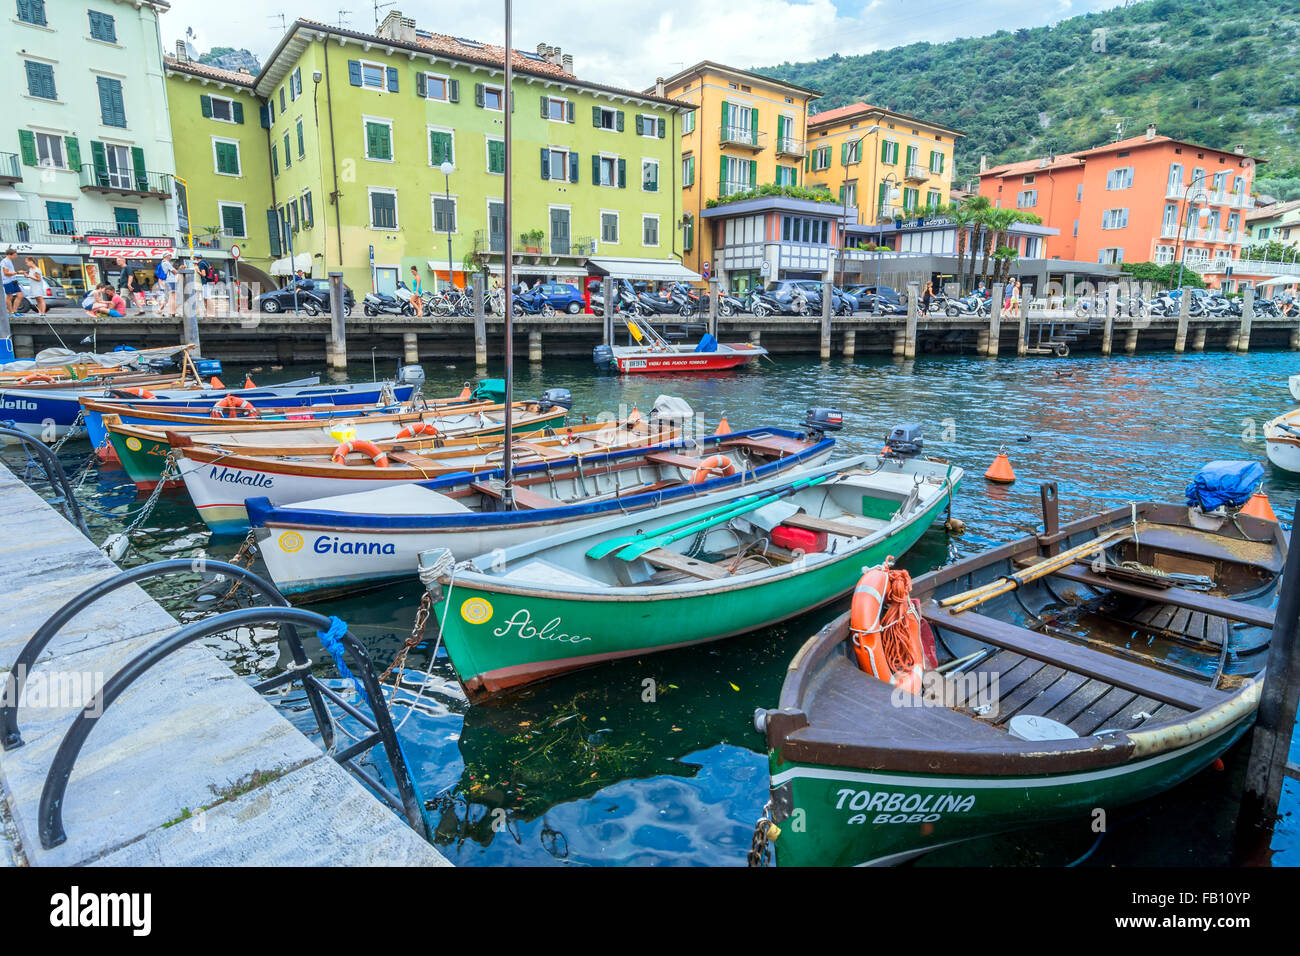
[437,486,948,698]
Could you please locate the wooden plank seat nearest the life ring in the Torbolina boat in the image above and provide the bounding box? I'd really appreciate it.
[922,592,1227,710]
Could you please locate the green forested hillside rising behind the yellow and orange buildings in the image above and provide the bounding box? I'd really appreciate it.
[755,0,1300,196]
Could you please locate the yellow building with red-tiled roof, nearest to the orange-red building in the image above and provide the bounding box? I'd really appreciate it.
[805,103,962,225]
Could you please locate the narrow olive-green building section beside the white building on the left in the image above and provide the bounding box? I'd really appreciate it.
[163,51,278,289]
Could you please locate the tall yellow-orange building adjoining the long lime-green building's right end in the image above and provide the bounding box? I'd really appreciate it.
[646,60,822,274]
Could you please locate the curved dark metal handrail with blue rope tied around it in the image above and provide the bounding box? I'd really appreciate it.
[26,582,430,849]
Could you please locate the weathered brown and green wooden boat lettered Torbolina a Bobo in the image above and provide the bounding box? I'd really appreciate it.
[755,486,1287,866]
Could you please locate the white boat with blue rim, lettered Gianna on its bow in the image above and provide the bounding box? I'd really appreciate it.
[244,423,835,594]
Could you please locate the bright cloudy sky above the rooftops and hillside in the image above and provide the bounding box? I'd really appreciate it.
[163,0,1121,88]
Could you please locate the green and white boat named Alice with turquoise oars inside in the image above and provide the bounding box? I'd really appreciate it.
[420,455,962,700]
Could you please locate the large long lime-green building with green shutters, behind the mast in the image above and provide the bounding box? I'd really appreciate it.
[253,12,693,295]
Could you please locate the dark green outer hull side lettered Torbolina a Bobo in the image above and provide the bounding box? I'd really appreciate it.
[770,711,1255,866]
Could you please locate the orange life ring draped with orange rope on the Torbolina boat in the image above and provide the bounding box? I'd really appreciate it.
[849,558,926,695]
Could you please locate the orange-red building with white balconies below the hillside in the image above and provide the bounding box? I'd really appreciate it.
[980,125,1262,285]
